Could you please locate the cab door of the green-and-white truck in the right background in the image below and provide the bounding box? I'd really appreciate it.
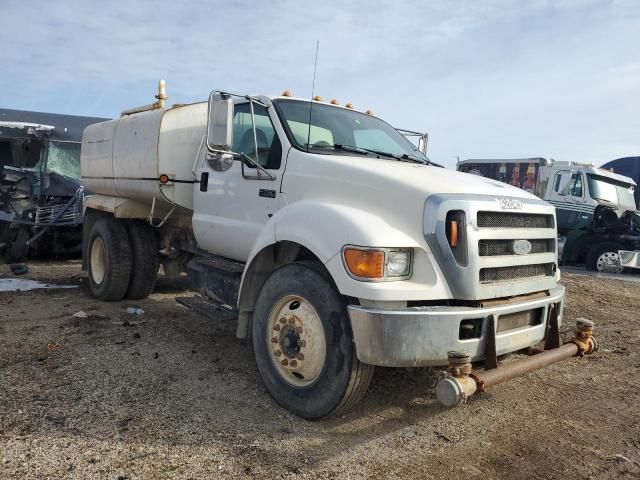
[547,170,585,233]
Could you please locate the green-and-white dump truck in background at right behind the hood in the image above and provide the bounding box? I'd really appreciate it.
[457,158,640,273]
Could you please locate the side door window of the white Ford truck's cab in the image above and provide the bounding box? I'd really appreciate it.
[232,103,282,170]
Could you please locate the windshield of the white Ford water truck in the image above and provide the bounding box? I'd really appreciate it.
[273,99,429,163]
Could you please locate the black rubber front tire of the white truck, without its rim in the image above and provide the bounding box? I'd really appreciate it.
[252,263,374,420]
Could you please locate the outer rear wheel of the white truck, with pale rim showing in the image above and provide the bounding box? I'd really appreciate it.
[87,218,132,302]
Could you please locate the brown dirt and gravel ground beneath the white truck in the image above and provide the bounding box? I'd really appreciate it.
[0,261,640,479]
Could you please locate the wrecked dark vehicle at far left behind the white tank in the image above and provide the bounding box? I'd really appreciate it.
[0,109,105,262]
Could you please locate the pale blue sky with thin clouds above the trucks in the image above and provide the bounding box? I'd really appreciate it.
[0,0,640,168]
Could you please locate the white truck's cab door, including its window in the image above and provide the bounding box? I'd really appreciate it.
[192,102,282,261]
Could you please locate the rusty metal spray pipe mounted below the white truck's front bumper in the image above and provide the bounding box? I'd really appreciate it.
[436,318,598,407]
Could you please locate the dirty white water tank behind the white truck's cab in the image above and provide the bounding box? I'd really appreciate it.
[80,102,207,210]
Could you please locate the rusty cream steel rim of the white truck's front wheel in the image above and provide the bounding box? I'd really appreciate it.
[267,295,327,387]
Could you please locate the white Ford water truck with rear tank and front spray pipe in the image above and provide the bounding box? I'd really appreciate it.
[81,83,593,419]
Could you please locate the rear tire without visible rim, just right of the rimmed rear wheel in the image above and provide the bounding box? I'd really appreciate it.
[126,222,160,300]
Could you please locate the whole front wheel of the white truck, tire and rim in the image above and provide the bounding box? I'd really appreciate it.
[252,263,374,419]
